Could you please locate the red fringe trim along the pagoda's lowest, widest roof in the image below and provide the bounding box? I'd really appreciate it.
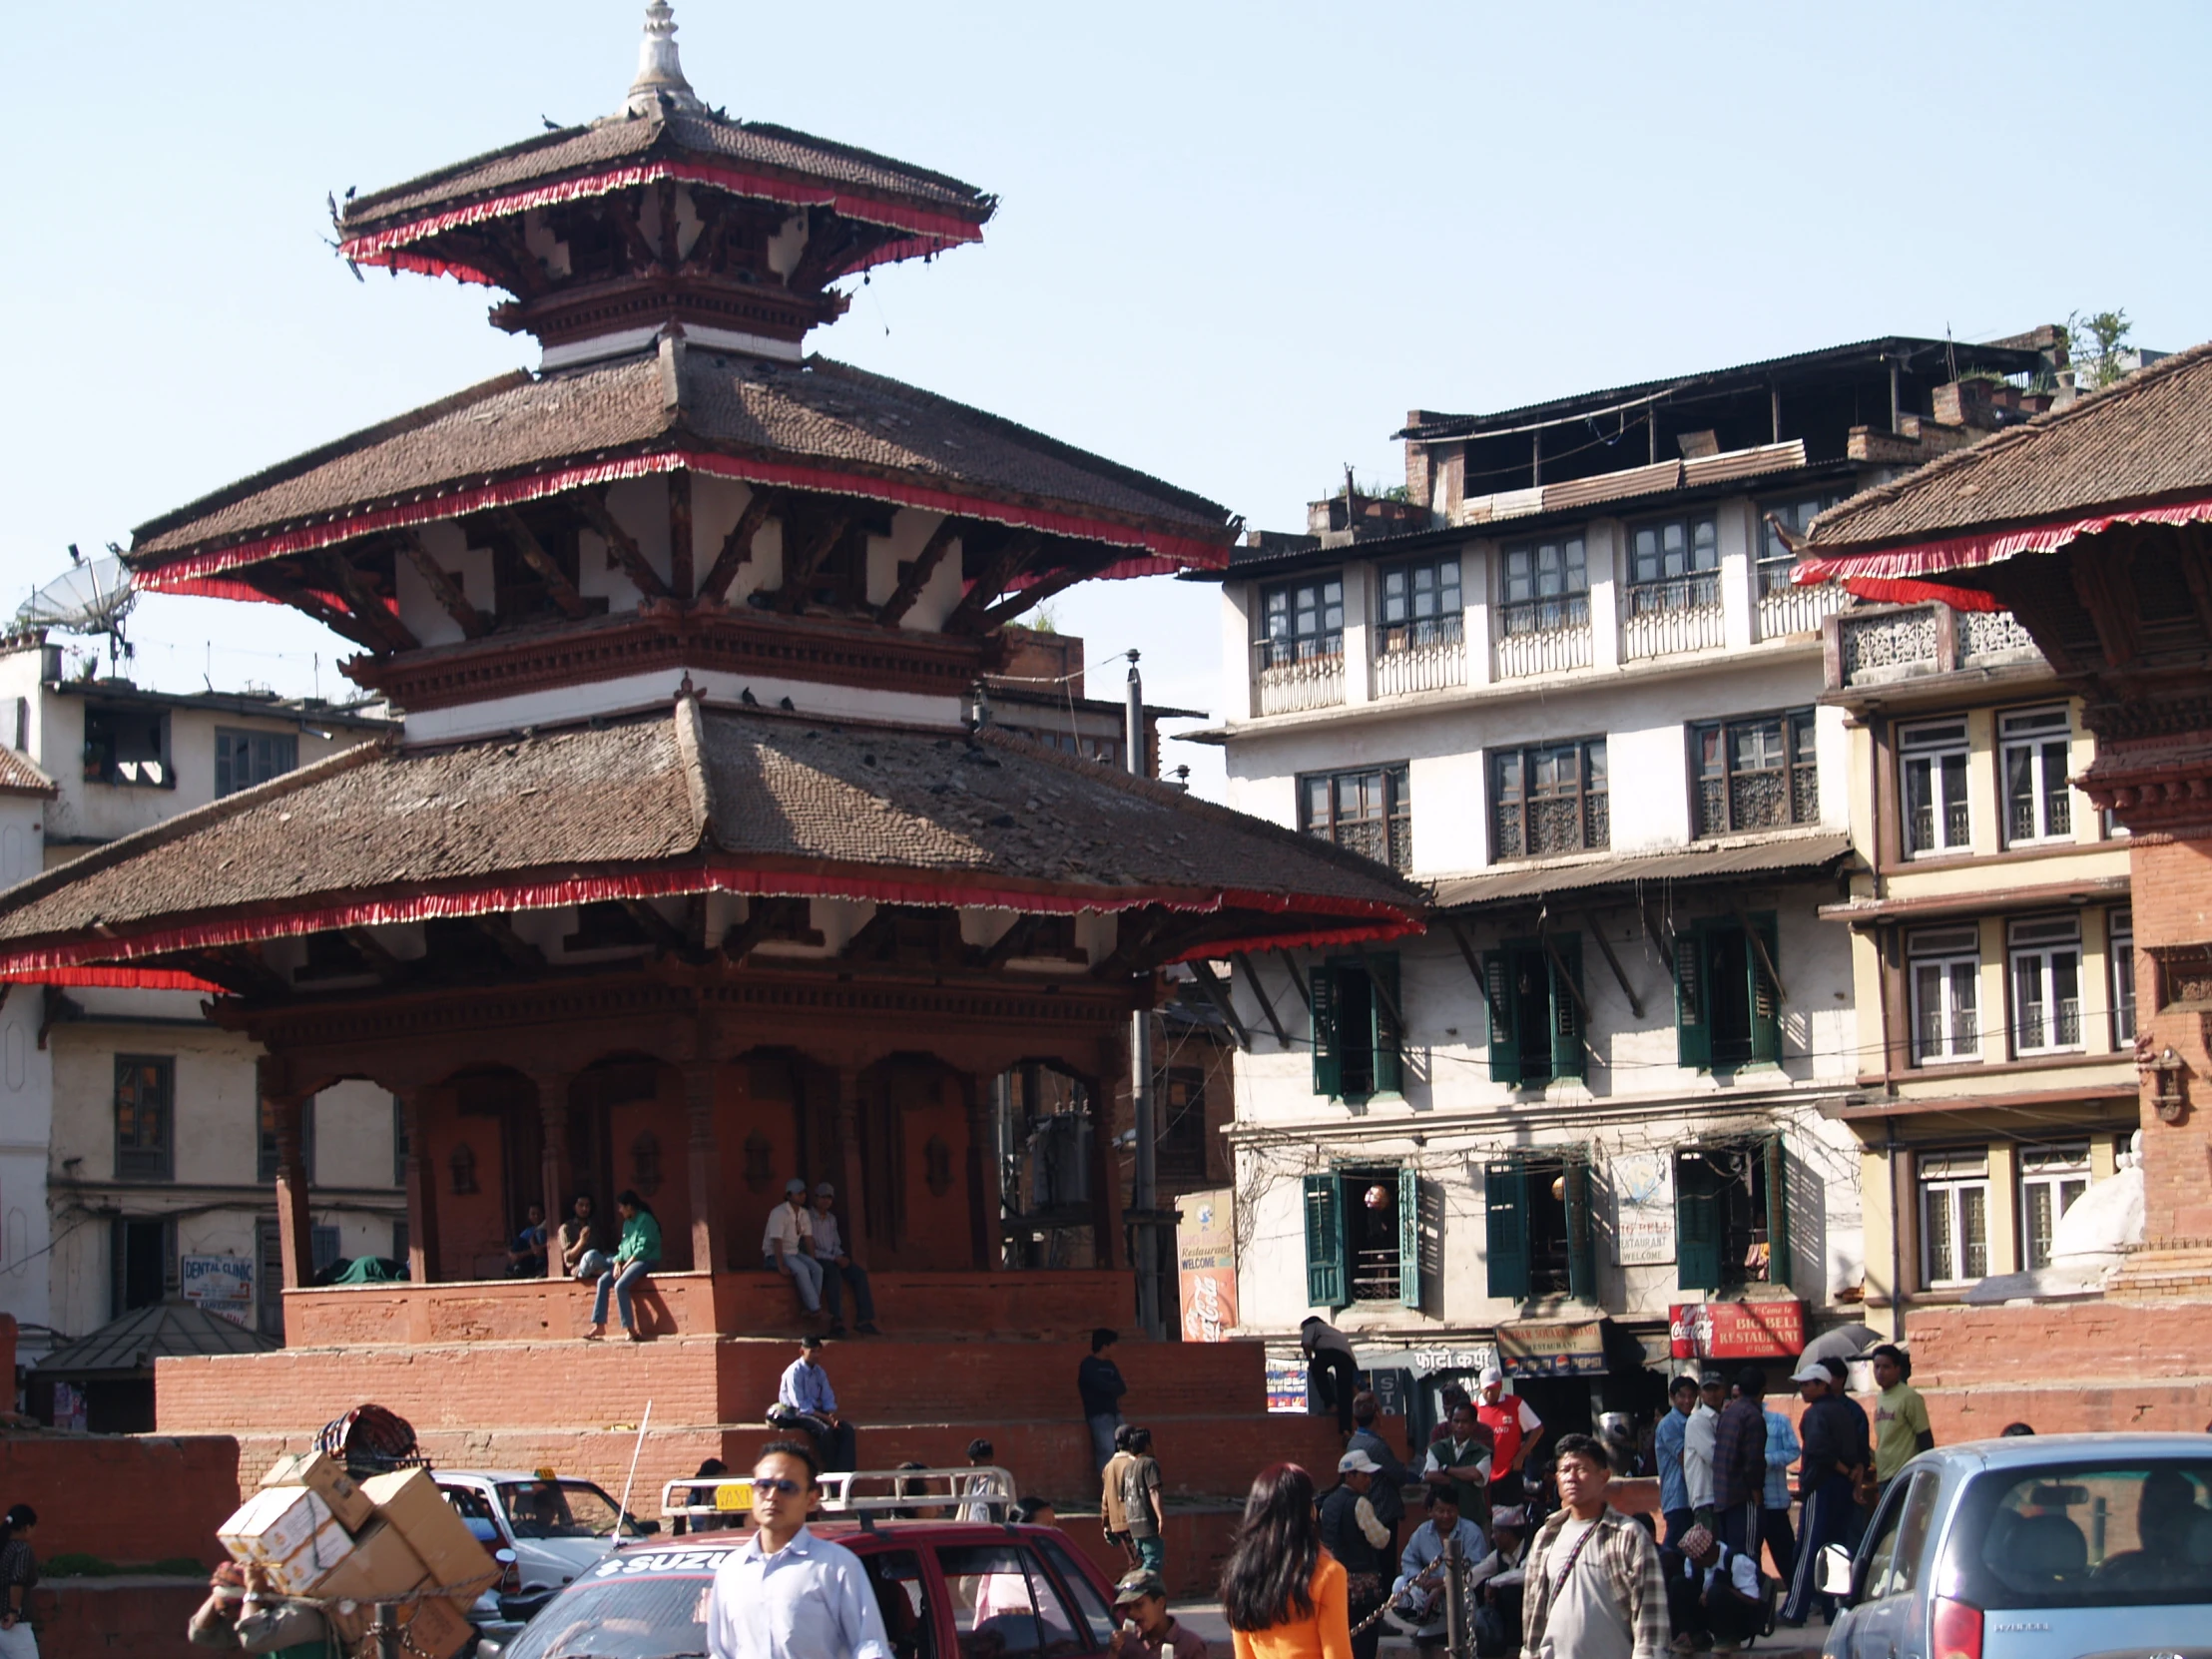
[0,860,1417,989]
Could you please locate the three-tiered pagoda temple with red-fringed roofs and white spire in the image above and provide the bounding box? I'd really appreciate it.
[0,0,1417,1530]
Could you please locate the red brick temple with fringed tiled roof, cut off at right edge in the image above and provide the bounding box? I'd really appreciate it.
[1796,345,2212,1433]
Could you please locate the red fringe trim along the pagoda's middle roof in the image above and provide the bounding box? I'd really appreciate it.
[137,449,1230,597]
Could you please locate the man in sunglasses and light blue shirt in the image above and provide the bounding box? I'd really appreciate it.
[706,1440,891,1659]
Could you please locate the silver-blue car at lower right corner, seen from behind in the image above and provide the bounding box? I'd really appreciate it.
[1821,1433,2212,1659]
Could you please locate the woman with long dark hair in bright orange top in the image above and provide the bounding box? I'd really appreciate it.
[1221,1462,1352,1659]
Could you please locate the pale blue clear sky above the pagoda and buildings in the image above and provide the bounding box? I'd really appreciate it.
[0,0,2212,801]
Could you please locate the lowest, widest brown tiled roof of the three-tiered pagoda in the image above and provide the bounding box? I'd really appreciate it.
[0,701,1420,966]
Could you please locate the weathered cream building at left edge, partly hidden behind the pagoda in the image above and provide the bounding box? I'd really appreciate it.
[0,633,407,1426]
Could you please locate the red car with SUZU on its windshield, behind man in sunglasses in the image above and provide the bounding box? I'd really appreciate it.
[487,1517,1115,1659]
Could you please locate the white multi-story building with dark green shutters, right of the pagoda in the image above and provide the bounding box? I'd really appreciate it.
[1185,336,2052,1426]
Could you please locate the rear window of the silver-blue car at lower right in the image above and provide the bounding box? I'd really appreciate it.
[1946,1455,2212,1610]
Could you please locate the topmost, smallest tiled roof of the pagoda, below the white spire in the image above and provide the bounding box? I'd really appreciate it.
[340,111,993,237]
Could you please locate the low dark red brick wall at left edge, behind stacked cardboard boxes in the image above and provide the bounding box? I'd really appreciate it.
[0,1433,239,1566]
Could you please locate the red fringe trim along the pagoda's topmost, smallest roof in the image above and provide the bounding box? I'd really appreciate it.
[338,162,982,287]
